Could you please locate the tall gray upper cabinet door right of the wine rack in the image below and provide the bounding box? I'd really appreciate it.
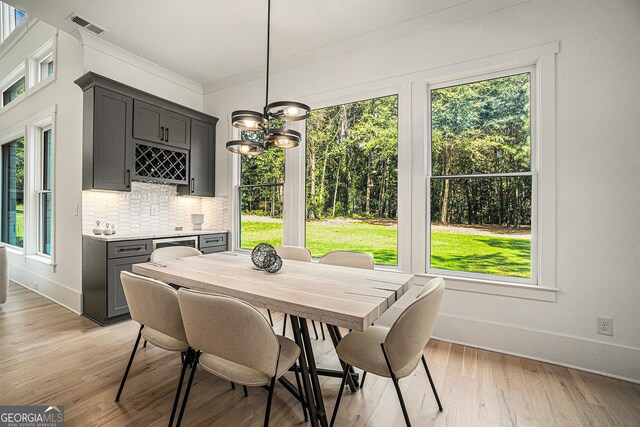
[178,119,216,197]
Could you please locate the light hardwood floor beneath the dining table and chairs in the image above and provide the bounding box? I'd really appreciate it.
[0,284,640,427]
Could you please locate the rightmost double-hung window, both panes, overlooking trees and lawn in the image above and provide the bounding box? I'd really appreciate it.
[427,68,536,283]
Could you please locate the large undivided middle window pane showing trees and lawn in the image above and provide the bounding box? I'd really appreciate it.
[306,95,398,265]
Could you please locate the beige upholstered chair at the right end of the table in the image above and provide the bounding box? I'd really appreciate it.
[331,278,445,426]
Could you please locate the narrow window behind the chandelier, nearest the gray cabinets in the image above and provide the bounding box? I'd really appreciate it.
[238,131,284,249]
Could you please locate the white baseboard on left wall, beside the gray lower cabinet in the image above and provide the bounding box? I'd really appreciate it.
[9,264,82,314]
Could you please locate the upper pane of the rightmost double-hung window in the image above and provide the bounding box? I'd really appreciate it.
[431,73,531,176]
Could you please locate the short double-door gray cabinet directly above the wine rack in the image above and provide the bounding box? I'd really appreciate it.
[133,99,191,149]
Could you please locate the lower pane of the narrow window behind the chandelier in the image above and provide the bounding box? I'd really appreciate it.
[240,185,284,249]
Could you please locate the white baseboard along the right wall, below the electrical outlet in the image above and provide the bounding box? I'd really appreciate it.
[433,313,640,384]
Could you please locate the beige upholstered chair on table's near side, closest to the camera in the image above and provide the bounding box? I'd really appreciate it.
[177,288,306,426]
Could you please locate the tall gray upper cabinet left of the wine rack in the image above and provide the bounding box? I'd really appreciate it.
[82,87,133,191]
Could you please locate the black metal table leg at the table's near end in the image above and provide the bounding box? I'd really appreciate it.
[290,316,329,427]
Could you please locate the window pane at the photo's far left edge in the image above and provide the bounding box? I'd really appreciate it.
[2,138,24,247]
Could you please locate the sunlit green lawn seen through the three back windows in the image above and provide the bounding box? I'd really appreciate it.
[242,221,531,277]
